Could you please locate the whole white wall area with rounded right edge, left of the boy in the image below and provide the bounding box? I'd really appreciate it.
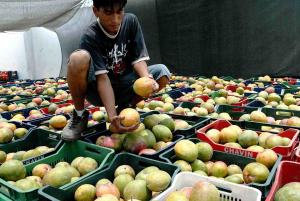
[0,27,62,79]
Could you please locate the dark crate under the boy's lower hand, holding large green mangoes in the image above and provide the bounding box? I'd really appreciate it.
[84,130,184,159]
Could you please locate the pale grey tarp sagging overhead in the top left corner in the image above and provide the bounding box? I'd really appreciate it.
[0,0,85,31]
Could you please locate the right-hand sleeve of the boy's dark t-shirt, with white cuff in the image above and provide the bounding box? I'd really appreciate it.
[132,16,150,65]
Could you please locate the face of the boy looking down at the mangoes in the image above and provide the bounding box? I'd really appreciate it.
[93,5,124,35]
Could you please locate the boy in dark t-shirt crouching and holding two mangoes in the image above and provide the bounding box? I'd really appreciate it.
[62,0,170,141]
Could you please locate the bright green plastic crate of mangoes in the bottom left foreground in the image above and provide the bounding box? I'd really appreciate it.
[0,140,114,201]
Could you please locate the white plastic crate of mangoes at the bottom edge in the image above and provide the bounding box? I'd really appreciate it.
[152,172,261,201]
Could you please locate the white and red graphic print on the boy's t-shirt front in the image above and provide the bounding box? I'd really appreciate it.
[104,43,128,75]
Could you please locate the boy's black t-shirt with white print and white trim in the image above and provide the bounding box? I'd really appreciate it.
[80,13,149,83]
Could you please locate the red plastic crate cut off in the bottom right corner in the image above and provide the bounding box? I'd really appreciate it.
[266,161,300,201]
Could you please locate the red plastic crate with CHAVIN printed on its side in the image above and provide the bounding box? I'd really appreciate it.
[197,119,299,160]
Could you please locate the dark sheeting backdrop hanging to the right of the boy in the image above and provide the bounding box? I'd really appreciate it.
[157,0,300,77]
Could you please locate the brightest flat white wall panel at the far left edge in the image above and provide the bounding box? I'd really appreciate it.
[0,32,29,79]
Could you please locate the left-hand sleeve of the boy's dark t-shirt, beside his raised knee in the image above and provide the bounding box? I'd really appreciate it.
[79,35,108,75]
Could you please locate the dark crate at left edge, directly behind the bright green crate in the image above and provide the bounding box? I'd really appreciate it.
[0,128,62,164]
